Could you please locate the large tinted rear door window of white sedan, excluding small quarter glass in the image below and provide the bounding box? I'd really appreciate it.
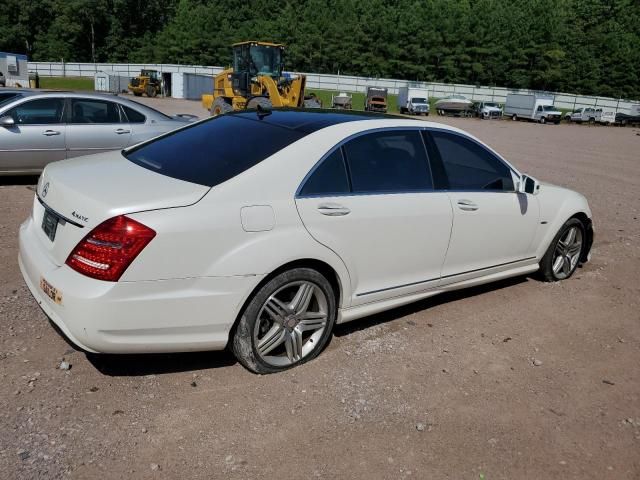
[344,130,433,193]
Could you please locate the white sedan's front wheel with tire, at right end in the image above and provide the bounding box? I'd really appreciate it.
[540,218,585,282]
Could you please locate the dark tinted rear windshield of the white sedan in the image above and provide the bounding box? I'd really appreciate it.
[124,115,305,187]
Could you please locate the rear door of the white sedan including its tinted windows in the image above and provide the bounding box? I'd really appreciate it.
[296,129,452,305]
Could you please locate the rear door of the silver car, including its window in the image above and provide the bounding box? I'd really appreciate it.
[66,98,131,158]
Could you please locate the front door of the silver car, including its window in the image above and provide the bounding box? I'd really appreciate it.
[0,97,65,173]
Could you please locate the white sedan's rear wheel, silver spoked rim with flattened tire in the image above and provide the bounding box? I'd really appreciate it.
[232,268,337,374]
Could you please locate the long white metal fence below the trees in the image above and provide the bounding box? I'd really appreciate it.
[29,62,640,113]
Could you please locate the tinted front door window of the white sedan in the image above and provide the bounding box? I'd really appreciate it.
[431,132,514,191]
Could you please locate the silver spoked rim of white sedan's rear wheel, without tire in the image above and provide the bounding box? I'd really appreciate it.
[253,280,329,367]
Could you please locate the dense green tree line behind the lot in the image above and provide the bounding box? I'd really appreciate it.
[0,0,640,99]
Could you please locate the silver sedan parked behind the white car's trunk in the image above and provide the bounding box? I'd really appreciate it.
[0,90,197,175]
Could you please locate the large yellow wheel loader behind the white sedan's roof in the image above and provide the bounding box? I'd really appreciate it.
[202,41,320,116]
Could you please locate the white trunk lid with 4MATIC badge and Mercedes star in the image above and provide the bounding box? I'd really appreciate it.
[33,152,210,265]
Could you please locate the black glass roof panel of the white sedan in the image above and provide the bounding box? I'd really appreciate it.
[228,108,416,134]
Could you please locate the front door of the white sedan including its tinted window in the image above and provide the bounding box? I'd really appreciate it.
[426,130,539,282]
